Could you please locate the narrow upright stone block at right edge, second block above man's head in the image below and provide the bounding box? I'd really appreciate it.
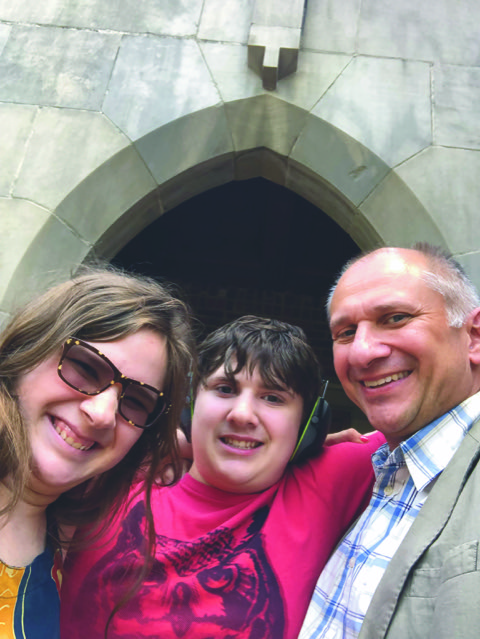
[433,65,480,149]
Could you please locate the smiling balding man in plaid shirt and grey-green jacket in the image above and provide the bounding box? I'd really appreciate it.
[300,244,480,639]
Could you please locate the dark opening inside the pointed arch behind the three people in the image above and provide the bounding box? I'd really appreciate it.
[113,178,359,426]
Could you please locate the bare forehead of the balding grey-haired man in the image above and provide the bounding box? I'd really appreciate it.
[330,249,443,326]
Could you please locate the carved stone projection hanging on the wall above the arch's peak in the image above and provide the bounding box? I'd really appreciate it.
[248,0,307,91]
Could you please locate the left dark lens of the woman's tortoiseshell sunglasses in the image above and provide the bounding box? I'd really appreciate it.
[59,344,115,395]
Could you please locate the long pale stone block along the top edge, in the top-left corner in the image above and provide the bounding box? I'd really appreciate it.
[0,0,202,36]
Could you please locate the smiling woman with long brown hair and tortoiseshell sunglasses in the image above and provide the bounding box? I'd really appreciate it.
[0,269,193,639]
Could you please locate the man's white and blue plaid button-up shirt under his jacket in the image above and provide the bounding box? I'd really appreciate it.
[300,393,480,639]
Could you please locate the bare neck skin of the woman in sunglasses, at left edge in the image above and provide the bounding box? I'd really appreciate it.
[0,484,48,567]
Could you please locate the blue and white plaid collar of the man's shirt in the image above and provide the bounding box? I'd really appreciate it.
[373,392,480,492]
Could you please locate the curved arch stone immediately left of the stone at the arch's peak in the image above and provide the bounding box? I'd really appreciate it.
[135,106,233,184]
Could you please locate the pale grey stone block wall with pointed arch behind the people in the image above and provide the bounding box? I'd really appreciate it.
[0,0,480,313]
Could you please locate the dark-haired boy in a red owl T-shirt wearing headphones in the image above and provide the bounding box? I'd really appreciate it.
[62,316,383,639]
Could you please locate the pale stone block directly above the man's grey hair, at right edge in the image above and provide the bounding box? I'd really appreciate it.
[397,147,480,254]
